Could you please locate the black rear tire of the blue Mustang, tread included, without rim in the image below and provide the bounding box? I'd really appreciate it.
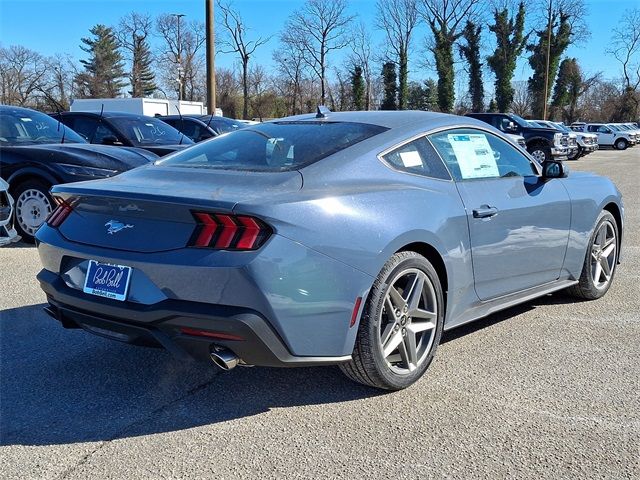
[340,251,444,390]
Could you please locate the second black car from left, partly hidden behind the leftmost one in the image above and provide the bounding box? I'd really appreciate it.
[51,112,193,157]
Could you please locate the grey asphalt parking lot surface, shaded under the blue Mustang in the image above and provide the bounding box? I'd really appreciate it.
[0,147,640,479]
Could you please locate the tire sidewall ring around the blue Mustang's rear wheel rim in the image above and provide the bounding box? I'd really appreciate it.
[361,252,444,389]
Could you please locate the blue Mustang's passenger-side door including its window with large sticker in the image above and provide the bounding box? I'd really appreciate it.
[429,128,571,300]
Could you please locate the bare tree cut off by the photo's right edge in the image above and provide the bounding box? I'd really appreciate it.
[607,8,640,90]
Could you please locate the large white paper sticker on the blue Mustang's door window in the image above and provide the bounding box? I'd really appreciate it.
[447,133,500,179]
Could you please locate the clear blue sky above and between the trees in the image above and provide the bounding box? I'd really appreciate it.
[0,0,640,89]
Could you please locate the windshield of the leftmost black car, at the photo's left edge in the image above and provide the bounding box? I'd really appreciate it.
[0,109,86,145]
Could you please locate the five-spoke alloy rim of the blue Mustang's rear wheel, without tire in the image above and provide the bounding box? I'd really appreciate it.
[378,268,438,375]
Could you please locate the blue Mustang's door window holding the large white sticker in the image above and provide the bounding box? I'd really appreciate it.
[429,129,538,181]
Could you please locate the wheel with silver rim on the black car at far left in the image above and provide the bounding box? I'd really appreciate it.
[12,180,54,243]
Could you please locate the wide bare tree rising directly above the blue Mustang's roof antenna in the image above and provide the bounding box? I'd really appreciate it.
[282,0,353,103]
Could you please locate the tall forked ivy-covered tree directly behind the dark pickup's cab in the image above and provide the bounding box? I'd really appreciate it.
[487,2,529,112]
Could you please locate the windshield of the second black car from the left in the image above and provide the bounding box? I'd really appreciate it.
[109,117,193,147]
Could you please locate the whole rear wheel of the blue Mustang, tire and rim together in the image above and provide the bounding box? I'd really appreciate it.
[340,252,444,390]
